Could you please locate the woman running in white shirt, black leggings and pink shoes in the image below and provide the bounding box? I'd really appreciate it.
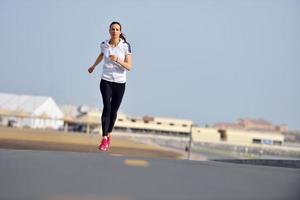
[88,22,132,151]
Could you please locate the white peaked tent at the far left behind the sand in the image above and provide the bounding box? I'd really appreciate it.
[0,93,64,129]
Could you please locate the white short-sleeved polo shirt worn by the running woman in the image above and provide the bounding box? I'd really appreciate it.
[100,39,131,83]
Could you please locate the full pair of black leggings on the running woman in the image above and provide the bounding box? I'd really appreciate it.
[100,79,125,136]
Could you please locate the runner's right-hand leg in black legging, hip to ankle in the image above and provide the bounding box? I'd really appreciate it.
[108,83,126,133]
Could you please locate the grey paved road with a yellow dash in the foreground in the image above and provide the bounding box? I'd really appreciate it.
[0,149,300,200]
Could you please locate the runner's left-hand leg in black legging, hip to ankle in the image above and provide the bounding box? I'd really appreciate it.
[100,80,112,136]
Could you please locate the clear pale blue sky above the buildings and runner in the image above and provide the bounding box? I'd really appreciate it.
[0,0,300,130]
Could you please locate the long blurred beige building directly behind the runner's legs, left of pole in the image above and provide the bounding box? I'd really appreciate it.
[61,106,193,136]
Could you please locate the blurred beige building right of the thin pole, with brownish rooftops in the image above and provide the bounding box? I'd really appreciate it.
[192,119,287,146]
